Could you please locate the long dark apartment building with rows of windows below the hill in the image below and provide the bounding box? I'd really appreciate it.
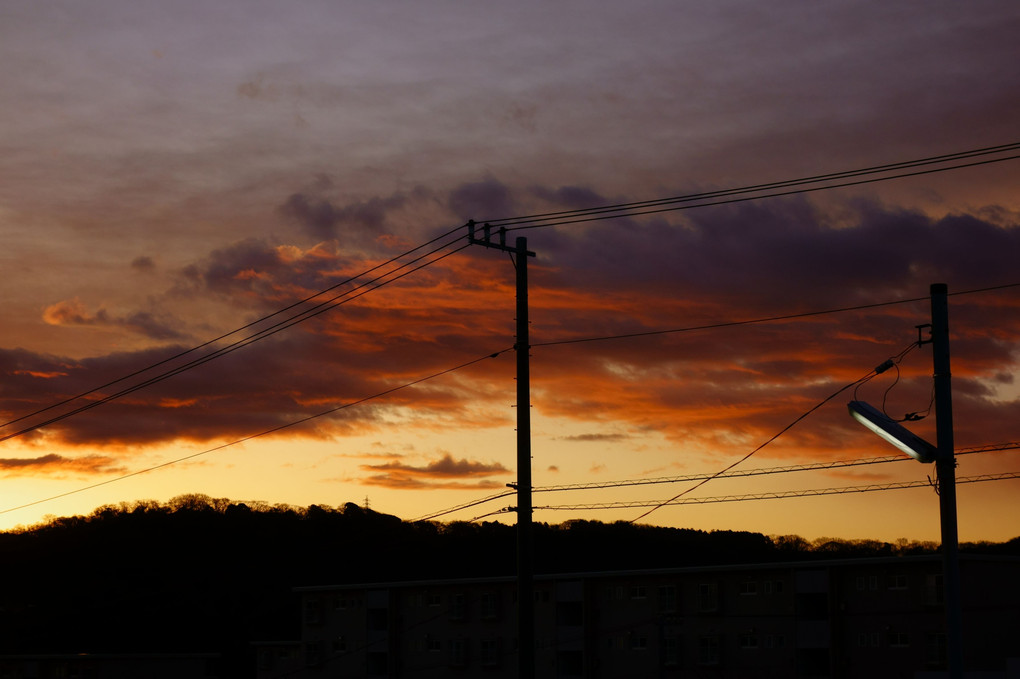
[275,556,1020,679]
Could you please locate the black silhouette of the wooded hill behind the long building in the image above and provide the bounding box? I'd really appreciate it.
[0,494,1020,677]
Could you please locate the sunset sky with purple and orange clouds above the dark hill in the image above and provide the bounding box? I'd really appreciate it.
[0,0,1020,541]
